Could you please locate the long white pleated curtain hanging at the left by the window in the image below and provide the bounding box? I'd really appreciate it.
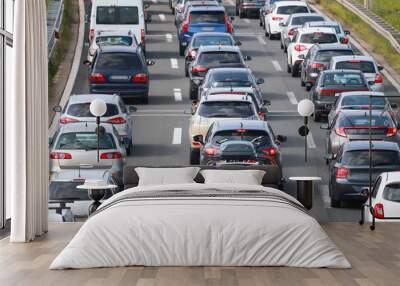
[6,0,49,242]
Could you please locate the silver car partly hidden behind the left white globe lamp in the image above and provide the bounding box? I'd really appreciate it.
[53,94,136,154]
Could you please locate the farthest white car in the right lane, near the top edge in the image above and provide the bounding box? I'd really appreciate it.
[264,1,311,39]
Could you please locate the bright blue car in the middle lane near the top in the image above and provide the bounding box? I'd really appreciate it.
[178,6,233,56]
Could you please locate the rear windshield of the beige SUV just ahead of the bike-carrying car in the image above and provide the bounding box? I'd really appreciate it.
[198,101,255,118]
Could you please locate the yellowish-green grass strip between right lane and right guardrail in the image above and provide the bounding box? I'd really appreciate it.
[316,0,400,74]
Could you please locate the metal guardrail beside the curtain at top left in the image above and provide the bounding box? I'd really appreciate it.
[47,0,64,58]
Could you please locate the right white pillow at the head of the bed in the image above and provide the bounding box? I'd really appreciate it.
[200,170,265,185]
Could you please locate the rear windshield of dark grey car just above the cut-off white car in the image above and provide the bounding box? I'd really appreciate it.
[341,150,400,166]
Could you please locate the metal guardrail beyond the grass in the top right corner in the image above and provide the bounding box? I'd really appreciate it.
[336,0,400,53]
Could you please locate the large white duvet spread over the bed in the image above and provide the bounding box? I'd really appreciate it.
[50,184,351,269]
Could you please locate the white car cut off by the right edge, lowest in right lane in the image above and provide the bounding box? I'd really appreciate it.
[364,172,400,222]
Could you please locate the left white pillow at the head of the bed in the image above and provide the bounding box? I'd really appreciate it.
[135,167,200,186]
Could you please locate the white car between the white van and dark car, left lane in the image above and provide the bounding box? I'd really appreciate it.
[88,30,139,62]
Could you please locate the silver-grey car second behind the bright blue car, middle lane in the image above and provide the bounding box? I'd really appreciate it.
[189,46,251,99]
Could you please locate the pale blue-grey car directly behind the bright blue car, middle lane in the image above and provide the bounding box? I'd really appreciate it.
[185,32,241,77]
